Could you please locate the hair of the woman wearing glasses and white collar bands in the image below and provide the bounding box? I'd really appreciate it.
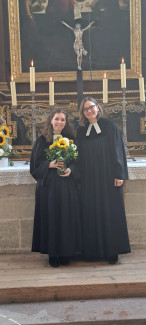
[79,96,103,126]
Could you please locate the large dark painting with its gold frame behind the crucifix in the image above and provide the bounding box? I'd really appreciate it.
[8,0,141,82]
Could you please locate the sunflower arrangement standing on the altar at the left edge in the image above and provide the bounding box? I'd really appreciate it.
[0,125,12,160]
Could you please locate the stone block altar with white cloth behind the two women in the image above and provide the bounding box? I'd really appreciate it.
[0,157,146,253]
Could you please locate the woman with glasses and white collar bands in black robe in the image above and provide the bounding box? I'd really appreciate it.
[77,97,130,264]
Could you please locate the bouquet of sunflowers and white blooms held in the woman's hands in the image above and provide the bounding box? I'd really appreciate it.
[45,136,78,175]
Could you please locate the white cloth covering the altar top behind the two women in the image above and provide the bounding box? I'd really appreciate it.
[0,158,146,186]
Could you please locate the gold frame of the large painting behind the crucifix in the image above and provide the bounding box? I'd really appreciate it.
[8,0,142,83]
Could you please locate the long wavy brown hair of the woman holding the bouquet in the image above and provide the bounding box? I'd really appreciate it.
[43,108,75,142]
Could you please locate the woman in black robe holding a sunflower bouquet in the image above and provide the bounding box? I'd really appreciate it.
[30,109,81,267]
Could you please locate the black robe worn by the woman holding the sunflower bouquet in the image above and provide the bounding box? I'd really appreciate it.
[30,135,81,256]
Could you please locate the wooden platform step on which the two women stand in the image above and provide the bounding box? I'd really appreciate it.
[0,250,146,304]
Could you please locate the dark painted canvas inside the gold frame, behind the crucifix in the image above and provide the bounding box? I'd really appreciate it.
[19,0,130,72]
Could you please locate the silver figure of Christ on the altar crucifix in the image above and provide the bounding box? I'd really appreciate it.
[61,21,94,70]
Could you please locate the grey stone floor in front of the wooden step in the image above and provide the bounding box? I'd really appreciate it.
[0,298,146,325]
